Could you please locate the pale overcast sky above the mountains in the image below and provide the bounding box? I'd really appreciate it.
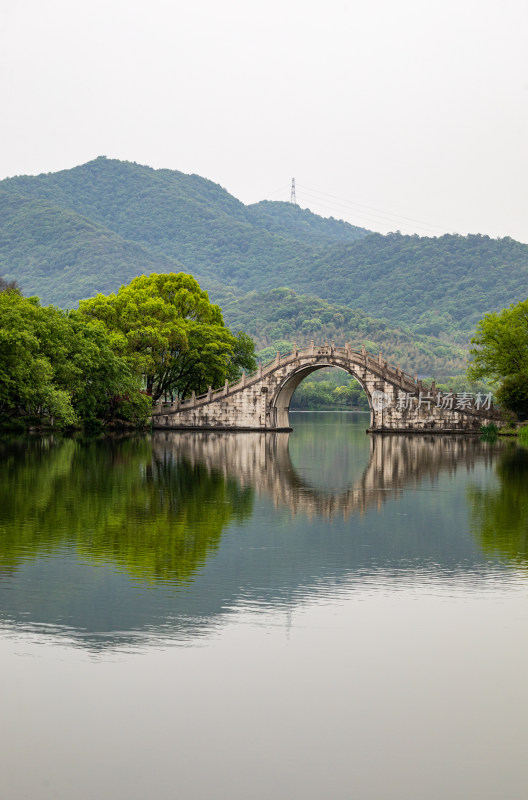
[0,0,528,242]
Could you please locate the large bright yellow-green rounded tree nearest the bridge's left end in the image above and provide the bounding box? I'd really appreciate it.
[80,272,255,401]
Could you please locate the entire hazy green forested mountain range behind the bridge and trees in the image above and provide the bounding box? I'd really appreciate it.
[0,157,528,376]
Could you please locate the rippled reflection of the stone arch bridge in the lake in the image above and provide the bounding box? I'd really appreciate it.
[153,431,500,519]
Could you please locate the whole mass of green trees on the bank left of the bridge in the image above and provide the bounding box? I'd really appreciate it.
[0,273,256,429]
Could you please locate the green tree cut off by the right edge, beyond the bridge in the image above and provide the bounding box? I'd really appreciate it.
[467,300,528,415]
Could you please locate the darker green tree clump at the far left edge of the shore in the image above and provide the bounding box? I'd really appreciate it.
[0,289,150,427]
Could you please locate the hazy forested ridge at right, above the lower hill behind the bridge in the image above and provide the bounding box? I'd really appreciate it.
[286,233,528,338]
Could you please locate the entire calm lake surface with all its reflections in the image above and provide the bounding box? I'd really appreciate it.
[0,413,528,800]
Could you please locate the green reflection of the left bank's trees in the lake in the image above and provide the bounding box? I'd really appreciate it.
[0,437,253,583]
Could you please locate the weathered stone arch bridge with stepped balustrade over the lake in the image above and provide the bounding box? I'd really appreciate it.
[152,342,500,433]
